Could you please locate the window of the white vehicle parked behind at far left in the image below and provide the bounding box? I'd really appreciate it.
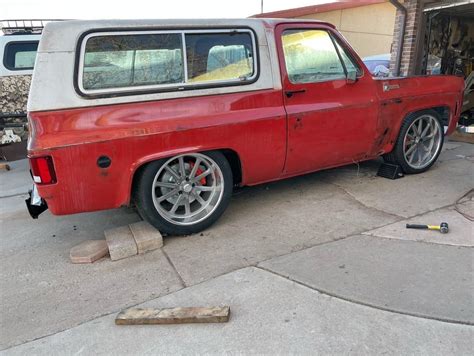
[3,41,39,70]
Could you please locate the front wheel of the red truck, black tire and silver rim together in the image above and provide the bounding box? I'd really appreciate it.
[383,110,444,174]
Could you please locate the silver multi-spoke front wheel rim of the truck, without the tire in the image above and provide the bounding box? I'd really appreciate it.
[403,115,443,169]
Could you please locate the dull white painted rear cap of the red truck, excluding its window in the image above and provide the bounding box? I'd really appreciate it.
[28,19,291,111]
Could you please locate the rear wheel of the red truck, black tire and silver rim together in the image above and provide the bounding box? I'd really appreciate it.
[135,151,233,235]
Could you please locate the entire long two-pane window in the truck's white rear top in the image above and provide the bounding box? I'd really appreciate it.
[78,30,256,94]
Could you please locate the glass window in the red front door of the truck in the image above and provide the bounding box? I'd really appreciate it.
[282,29,346,84]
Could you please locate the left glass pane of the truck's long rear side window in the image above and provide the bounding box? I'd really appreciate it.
[82,33,184,90]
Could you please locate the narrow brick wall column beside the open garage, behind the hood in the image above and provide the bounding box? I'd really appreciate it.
[390,0,424,76]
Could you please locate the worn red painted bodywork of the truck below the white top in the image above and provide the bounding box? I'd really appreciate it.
[28,23,463,215]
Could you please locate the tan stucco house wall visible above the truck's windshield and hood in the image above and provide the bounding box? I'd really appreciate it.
[299,2,396,57]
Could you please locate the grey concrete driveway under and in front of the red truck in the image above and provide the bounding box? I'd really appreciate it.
[0,141,474,355]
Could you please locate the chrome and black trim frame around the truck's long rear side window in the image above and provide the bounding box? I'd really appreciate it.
[74,27,260,98]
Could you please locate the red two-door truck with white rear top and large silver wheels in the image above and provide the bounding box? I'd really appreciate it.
[27,19,464,235]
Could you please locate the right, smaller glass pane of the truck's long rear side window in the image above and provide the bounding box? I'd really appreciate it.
[186,32,255,83]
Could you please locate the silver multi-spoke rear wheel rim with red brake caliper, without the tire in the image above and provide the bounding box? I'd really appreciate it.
[152,153,224,225]
